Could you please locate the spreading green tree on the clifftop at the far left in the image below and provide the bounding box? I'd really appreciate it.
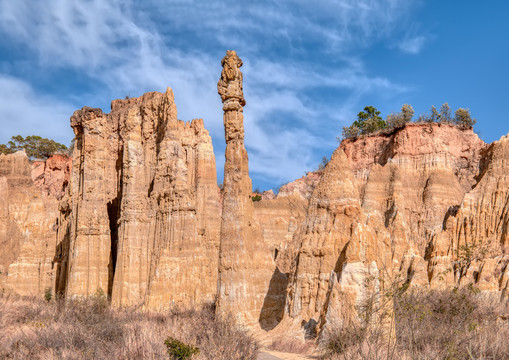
[0,135,68,159]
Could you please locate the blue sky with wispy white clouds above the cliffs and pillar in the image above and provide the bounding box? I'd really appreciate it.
[0,0,509,189]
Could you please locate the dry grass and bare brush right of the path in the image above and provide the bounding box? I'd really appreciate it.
[323,288,509,360]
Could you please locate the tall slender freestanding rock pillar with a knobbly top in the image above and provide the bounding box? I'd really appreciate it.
[217,50,274,325]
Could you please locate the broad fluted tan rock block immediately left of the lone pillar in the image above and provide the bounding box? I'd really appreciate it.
[57,88,220,308]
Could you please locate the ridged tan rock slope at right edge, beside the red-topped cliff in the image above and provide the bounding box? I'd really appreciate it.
[427,136,509,294]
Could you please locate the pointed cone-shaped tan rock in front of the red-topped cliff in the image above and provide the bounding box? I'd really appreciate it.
[287,149,391,333]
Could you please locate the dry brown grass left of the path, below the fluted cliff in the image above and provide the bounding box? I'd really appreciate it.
[0,295,259,360]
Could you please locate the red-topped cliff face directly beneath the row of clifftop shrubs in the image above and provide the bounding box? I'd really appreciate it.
[341,124,485,283]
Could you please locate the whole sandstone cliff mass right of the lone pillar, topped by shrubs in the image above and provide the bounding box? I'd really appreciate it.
[270,124,509,334]
